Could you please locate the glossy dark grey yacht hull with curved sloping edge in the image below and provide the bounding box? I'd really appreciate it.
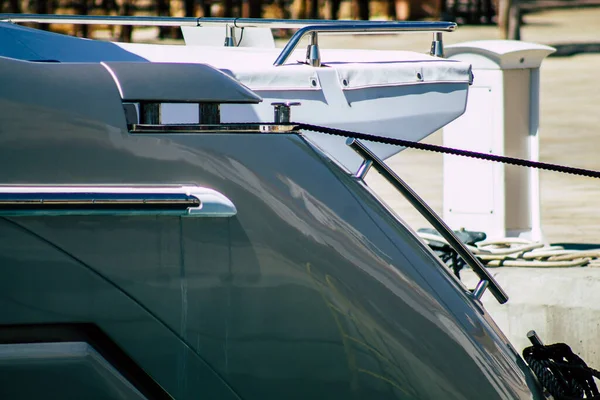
[0,54,542,400]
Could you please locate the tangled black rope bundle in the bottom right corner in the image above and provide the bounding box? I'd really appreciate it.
[523,343,600,400]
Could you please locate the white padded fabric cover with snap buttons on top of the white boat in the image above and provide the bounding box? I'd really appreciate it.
[117,43,471,90]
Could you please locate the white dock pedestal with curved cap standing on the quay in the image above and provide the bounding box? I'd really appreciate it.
[443,40,555,240]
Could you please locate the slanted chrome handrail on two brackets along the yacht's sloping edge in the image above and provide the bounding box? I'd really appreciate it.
[346,139,508,304]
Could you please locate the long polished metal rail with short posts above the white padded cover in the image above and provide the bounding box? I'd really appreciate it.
[0,14,456,67]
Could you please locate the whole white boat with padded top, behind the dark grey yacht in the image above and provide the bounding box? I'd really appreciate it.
[0,23,472,170]
